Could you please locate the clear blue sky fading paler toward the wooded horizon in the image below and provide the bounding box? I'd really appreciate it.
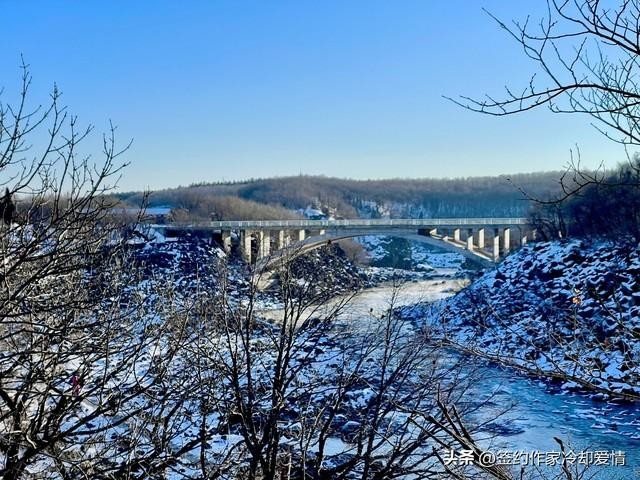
[0,0,624,190]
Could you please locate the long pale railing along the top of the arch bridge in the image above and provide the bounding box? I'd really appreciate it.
[155,217,529,230]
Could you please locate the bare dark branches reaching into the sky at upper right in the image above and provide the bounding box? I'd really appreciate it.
[453,0,640,210]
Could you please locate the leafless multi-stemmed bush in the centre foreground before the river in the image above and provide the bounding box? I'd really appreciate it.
[184,246,568,480]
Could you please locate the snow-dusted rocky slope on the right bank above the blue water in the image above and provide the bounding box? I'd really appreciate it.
[402,241,640,397]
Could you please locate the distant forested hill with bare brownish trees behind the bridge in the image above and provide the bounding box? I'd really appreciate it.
[119,172,561,219]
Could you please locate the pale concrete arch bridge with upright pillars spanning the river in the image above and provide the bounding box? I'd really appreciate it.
[154,218,535,270]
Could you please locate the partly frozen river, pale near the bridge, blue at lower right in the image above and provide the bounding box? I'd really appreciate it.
[263,272,640,479]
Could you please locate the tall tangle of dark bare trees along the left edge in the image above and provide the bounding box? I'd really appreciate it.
[0,63,201,479]
